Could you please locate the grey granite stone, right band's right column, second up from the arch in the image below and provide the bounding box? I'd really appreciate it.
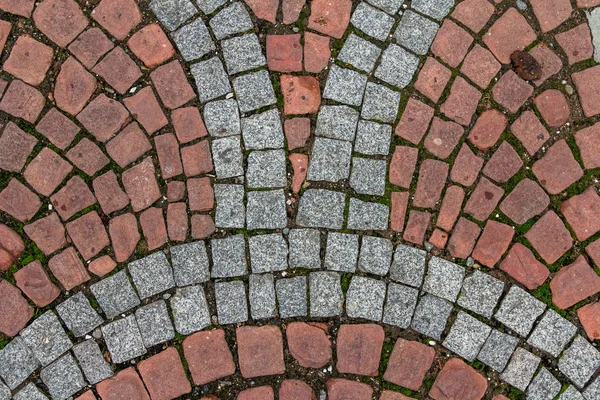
[350,157,387,196]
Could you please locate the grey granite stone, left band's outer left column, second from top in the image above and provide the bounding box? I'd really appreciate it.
[173,18,216,61]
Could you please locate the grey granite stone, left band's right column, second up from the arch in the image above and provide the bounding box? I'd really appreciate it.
[246,150,287,189]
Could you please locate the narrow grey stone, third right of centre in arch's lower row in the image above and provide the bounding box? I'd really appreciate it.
[383,282,419,329]
